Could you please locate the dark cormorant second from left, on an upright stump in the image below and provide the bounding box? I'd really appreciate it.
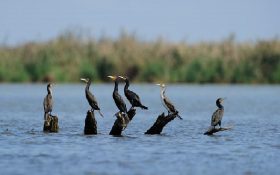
[81,78,104,117]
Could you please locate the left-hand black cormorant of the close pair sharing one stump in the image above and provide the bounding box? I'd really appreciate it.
[108,76,127,113]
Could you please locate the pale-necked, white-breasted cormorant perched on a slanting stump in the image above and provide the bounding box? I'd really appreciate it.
[156,84,183,120]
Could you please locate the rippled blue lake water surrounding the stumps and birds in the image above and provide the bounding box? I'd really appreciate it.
[0,84,280,175]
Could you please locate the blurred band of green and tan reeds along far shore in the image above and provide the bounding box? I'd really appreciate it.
[0,32,280,83]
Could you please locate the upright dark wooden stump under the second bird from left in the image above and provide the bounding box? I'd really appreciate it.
[84,110,97,135]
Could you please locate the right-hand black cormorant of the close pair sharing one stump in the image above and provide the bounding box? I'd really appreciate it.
[119,76,148,110]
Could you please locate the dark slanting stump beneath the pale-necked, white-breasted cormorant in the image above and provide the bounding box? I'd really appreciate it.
[145,113,176,134]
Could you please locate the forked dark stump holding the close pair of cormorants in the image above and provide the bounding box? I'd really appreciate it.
[109,108,136,136]
